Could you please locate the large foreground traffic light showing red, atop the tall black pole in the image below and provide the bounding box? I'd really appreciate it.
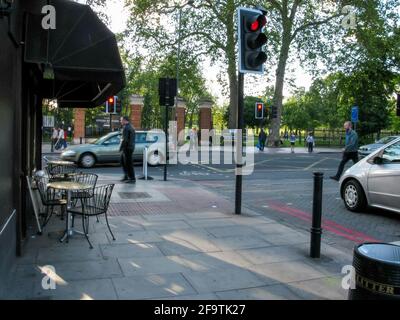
[238,8,267,74]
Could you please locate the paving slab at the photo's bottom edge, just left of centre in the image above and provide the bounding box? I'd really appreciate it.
[112,274,197,300]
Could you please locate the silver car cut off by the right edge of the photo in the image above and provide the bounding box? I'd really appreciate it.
[340,138,400,213]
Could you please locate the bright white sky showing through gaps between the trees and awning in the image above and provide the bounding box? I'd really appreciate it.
[107,0,312,105]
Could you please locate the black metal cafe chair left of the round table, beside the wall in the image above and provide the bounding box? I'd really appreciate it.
[35,176,67,228]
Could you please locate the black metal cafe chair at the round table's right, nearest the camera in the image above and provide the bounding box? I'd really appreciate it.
[68,184,115,249]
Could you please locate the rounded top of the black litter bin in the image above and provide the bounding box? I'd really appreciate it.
[358,243,400,265]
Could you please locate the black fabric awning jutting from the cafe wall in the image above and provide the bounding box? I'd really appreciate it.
[25,0,126,108]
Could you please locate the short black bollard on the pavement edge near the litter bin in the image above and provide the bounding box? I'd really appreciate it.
[310,172,324,258]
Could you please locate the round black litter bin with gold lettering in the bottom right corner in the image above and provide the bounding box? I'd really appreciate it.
[348,243,400,300]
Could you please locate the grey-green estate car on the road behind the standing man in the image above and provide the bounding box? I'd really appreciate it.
[61,130,171,168]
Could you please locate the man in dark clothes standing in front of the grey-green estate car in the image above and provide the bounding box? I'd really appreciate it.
[119,116,136,183]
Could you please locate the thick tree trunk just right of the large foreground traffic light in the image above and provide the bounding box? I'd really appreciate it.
[268,33,291,147]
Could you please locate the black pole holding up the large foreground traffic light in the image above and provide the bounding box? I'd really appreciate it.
[235,72,244,214]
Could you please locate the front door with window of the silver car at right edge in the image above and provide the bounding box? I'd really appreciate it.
[368,141,400,210]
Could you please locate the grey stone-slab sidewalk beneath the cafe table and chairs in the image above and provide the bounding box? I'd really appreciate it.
[5,175,352,300]
